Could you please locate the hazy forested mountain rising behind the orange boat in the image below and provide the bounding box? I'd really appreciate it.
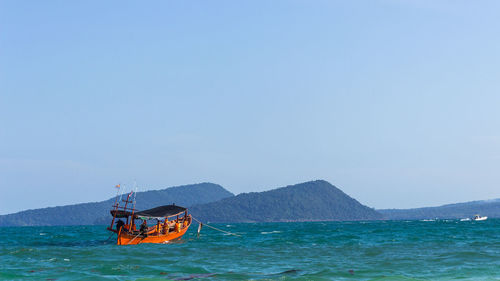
[0,183,234,226]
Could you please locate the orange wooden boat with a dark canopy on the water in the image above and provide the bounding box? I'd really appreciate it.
[107,189,192,245]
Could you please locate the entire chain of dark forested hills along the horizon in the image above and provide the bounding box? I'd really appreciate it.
[0,180,500,227]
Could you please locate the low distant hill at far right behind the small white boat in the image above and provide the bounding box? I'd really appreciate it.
[377,199,500,220]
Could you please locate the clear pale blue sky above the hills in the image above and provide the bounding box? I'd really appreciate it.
[0,0,500,214]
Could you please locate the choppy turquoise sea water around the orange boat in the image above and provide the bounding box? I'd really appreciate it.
[0,219,500,280]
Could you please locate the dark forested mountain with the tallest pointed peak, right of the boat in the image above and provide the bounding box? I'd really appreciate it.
[191,180,382,222]
